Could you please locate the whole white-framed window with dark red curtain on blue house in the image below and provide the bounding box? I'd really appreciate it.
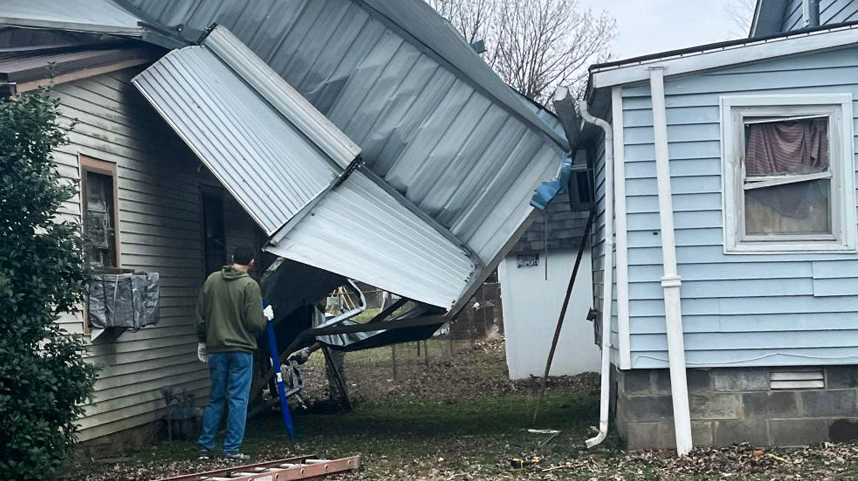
[722,95,856,253]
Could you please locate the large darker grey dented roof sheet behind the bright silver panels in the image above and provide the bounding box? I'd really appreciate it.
[117,0,566,277]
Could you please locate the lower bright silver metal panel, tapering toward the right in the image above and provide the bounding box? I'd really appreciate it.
[267,171,475,308]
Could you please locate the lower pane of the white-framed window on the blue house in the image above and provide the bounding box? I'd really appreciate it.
[745,179,832,235]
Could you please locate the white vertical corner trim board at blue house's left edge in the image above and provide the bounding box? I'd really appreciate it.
[611,87,632,369]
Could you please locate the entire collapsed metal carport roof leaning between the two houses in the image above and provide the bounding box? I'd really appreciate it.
[7,0,568,340]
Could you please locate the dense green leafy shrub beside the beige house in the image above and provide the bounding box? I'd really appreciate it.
[0,91,95,481]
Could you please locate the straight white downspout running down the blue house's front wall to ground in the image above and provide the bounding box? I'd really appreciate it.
[650,67,693,456]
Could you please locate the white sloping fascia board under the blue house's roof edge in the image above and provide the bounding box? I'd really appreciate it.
[591,25,858,89]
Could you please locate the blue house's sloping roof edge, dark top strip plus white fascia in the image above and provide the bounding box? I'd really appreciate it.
[588,22,858,95]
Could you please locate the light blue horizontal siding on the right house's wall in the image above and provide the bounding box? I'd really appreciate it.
[623,48,858,368]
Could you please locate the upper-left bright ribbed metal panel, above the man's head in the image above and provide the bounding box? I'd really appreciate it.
[133,46,337,234]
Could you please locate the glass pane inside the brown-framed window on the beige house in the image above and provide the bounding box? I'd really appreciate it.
[84,172,116,267]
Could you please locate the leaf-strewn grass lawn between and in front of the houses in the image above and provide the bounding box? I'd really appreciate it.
[66,341,858,481]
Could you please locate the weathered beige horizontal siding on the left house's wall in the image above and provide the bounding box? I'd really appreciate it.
[54,69,256,441]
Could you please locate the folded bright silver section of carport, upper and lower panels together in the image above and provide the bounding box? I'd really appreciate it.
[133,27,475,309]
